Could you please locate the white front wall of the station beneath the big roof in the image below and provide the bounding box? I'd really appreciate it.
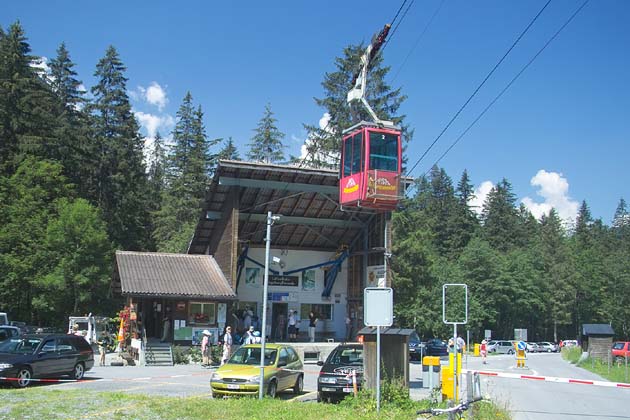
[236,248,348,340]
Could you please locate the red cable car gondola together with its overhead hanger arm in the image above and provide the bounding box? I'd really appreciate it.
[339,24,402,211]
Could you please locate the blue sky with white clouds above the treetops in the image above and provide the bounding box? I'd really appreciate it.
[0,0,630,224]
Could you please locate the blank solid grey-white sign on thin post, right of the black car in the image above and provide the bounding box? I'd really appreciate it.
[363,287,394,412]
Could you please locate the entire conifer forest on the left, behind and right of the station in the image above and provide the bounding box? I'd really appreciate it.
[0,23,630,341]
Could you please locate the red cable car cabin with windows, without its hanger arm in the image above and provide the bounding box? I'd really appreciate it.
[339,121,402,211]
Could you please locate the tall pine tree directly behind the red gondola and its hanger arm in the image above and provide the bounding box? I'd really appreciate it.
[304,44,413,167]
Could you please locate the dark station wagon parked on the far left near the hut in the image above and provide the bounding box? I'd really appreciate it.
[0,334,94,388]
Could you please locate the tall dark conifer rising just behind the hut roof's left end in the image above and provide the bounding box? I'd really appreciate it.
[90,46,149,250]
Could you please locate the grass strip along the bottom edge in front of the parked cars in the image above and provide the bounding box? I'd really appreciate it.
[0,387,510,420]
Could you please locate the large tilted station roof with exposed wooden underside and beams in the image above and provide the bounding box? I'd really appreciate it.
[188,160,411,254]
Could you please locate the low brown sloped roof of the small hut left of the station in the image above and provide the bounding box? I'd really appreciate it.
[116,251,236,300]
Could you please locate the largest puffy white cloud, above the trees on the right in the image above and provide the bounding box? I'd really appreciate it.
[521,169,579,222]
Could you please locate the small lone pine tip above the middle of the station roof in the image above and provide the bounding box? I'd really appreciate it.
[247,104,285,163]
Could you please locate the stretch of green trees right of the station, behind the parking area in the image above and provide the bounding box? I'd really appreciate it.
[392,166,630,341]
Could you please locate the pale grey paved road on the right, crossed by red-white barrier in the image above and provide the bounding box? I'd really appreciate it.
[468,353,630,420]
